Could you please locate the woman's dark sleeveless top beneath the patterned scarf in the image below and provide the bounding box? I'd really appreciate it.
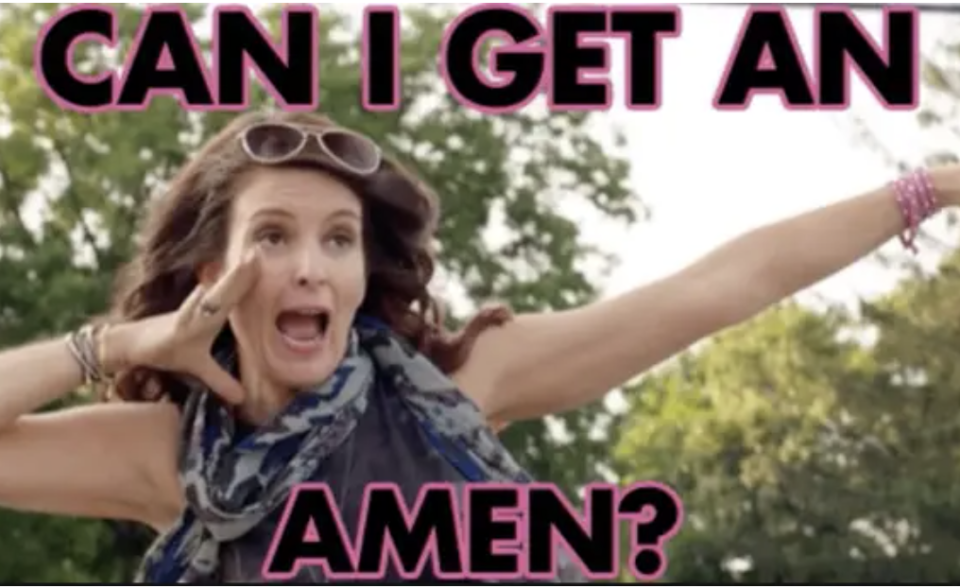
[220,387,465,584]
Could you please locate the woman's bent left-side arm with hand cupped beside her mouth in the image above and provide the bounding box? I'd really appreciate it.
[0,255,260,529]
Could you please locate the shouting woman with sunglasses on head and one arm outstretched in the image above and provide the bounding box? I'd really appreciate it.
[0,114,960,583]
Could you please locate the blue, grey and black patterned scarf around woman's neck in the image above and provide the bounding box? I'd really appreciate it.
[137,319,548,584]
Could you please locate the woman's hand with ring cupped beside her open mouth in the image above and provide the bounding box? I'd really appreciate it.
[104,252,260,404]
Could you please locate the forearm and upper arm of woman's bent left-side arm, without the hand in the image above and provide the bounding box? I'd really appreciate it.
[0,331,178,526]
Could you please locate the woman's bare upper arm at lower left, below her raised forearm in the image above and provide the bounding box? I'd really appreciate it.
[0,403,182,528]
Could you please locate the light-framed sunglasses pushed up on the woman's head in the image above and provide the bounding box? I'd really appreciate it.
[240,123,383,176]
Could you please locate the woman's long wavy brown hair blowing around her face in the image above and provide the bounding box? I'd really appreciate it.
[107,113,509,404]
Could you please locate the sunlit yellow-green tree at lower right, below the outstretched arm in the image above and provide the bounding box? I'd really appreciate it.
[617,256,960,584]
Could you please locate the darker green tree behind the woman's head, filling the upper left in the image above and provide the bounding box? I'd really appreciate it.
[0,4,638,582]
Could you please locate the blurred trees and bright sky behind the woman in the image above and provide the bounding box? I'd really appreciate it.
[0,3,960,584]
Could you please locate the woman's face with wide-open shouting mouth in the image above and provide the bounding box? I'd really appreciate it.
[218,168,366,389]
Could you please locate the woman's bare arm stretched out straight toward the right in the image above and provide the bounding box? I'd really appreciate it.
[456,167,960,421]
